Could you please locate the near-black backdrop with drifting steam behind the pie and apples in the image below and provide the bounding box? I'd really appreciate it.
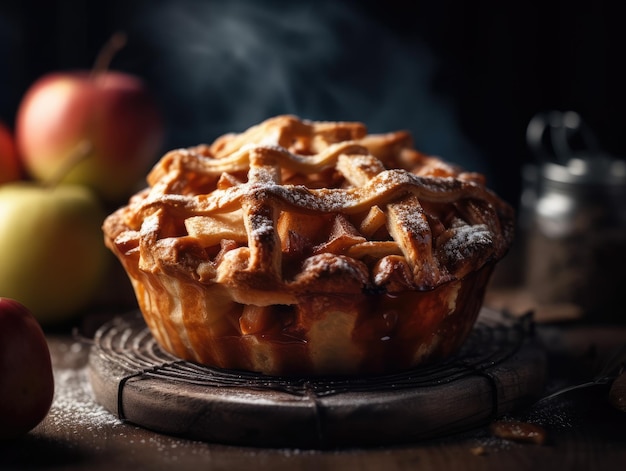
[0,0,626,205]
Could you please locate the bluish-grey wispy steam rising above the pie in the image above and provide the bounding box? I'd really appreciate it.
[135,0,485,171]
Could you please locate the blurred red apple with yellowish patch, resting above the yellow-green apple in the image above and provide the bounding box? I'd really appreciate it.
[16,61,164,202]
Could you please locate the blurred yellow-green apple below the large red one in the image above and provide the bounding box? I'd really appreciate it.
[0,181,109,324]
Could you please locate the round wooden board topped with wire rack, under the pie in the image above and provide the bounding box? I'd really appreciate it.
[89,309,547,448]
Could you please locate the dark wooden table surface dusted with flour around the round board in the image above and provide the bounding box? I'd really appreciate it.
[0,290,626,471]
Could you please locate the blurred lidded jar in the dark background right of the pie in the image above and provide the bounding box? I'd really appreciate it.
[520,112,626,322]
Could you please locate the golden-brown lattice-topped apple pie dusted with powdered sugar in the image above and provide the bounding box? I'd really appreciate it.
[103,116,514,375]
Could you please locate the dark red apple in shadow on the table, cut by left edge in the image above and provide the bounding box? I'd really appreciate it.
[0,297,54,439]
